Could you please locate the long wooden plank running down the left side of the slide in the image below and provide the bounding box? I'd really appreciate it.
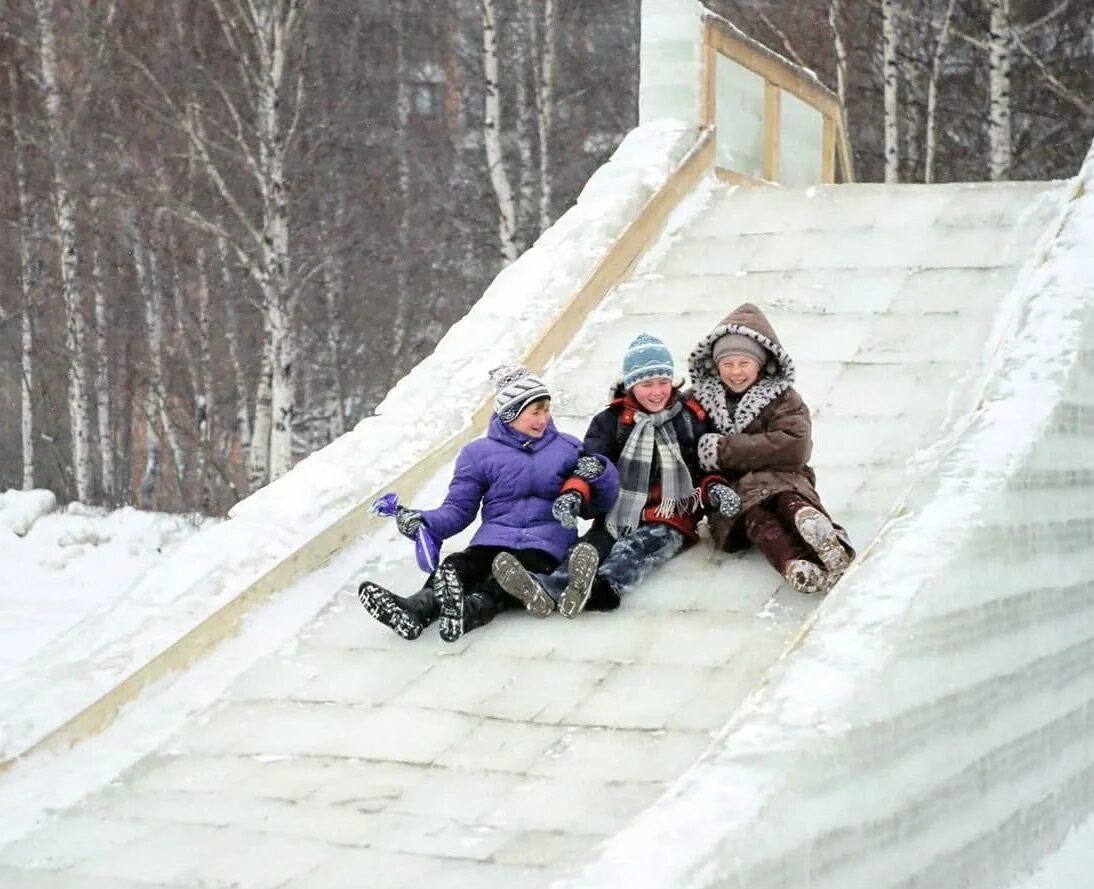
[0,130,714,774]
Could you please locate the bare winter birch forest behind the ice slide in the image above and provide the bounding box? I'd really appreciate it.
[0,0,1094,514]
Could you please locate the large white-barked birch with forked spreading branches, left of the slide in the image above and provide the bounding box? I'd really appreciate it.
[138,0,310,487]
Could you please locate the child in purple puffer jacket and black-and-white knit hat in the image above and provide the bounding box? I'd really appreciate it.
[358,365,619,642]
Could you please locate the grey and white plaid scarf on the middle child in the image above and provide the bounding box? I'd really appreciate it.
[607,401,699,539]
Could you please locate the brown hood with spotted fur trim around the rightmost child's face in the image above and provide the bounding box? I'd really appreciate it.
[687,303,796,434]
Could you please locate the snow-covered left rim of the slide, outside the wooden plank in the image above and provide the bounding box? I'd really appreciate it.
[0,120,697,759]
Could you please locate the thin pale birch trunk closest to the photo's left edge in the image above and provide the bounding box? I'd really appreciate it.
[8,66,36,491]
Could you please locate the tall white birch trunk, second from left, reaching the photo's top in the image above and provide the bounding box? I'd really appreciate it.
[34,0,93,502]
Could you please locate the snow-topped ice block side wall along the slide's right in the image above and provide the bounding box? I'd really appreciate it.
[566,148,1094,889]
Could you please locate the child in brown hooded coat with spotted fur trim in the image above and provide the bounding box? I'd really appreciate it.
[688,303,854,593]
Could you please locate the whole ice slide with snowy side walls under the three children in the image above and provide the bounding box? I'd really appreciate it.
[6,10,1094,889]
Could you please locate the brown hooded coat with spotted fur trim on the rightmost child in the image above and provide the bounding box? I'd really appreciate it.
[688,303,846,552]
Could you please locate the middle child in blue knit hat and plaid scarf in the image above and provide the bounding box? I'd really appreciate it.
[493,334,738,618]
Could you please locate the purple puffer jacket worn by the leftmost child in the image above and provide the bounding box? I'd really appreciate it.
[422,414,619,560]
